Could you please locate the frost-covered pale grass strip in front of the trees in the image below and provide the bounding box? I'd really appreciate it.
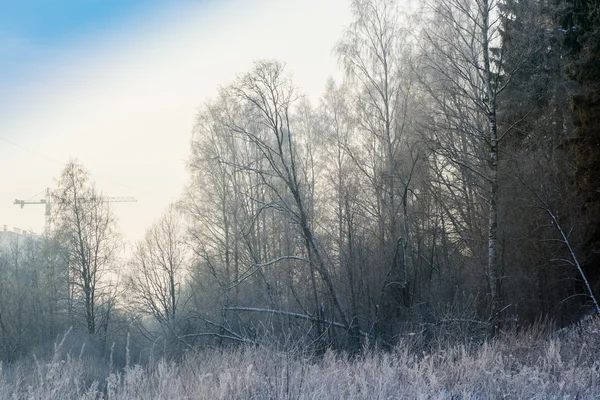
[0,319,600,400]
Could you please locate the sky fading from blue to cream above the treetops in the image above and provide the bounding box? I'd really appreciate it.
[0,0,351,247]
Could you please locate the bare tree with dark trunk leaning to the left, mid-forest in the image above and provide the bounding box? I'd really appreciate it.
[219,61,349,332]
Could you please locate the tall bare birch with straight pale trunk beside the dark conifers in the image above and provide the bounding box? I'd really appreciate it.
[419,0,536,314]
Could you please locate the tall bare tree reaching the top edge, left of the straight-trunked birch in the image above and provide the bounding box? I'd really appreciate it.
[335,0,422,334]
